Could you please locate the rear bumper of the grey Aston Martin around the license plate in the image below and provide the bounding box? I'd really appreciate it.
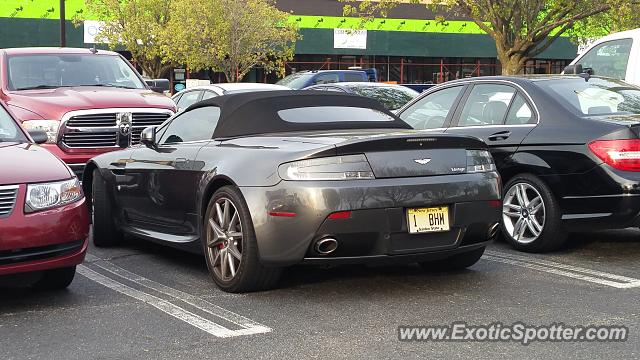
[241,173,501,266]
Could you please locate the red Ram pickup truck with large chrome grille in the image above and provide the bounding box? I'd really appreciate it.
[0,48,175,176]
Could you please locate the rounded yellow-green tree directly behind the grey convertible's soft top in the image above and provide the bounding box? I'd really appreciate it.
[165,0,299,82]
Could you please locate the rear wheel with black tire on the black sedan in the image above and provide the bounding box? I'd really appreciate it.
[501,174,567,252]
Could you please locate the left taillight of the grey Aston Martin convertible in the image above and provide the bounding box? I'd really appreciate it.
[278,154,375,180]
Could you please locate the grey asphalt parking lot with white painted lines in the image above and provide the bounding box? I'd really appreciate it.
[0,230,640,359]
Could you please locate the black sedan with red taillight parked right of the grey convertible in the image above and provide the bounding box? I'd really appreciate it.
[399,74,640,252]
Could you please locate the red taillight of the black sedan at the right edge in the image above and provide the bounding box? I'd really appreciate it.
[589,139,640,171]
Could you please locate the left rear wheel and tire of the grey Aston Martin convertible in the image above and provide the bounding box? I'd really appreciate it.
[202,186,282,293]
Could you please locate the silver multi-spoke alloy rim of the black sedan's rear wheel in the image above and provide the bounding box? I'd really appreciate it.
[502,183,545,244]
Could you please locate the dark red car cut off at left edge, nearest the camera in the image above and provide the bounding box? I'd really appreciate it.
[0,101,89,289]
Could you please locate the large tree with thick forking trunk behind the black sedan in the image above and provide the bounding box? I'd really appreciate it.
[341,0,640,75]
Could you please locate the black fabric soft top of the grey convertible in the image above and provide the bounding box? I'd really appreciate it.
[185,90,411,138]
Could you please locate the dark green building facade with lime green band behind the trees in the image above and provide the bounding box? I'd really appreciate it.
[0,0,577,82]
